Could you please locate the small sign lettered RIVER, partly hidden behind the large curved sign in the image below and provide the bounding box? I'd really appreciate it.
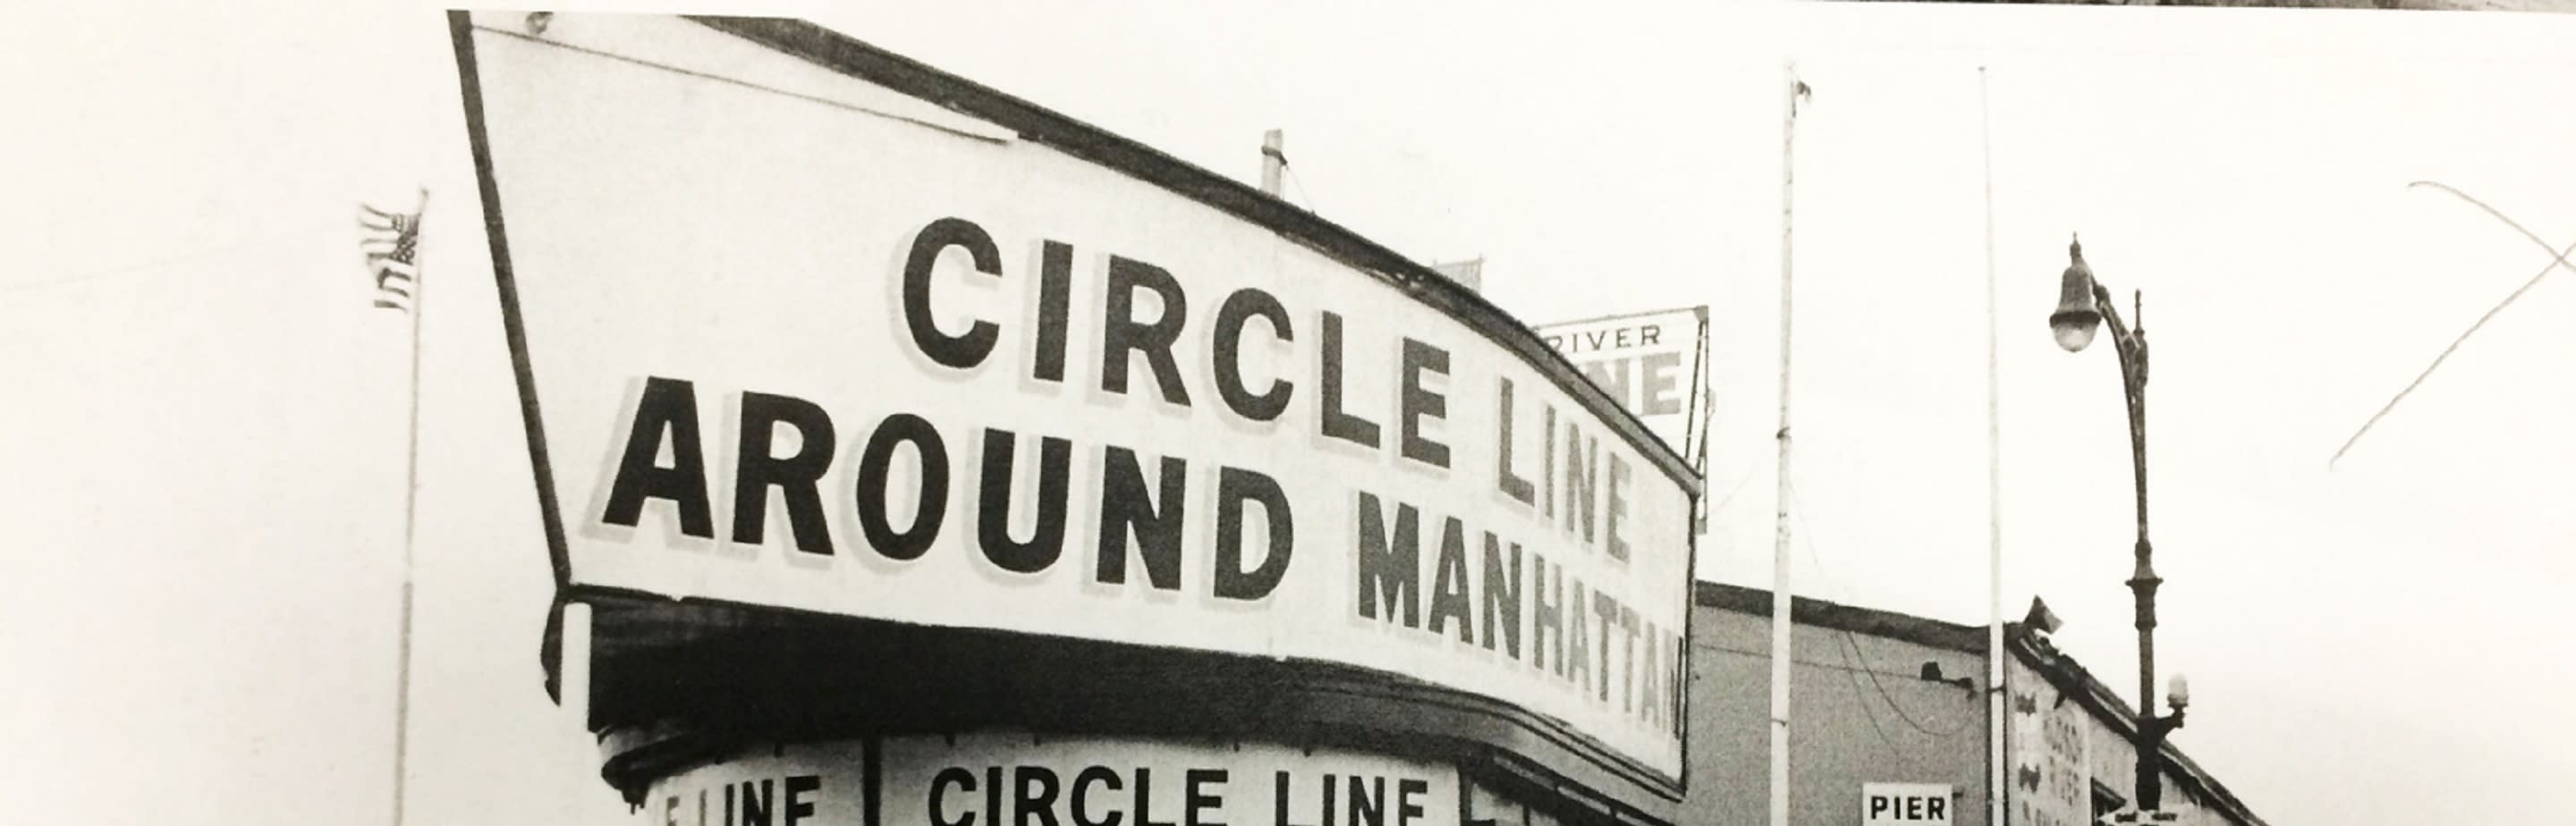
[1530,307,1707,451]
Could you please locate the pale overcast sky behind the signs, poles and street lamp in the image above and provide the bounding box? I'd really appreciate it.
[0,3,2576,823]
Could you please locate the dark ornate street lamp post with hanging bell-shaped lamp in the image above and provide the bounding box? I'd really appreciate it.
[2048,232,2190,811]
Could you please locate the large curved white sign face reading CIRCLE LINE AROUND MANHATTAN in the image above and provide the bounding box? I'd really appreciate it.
[471,13,1695,780]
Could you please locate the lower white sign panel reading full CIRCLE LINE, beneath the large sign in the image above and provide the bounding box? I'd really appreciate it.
[878,736,1458,826]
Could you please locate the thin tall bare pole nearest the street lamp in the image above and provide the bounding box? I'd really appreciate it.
[1976,67,2004,826]
